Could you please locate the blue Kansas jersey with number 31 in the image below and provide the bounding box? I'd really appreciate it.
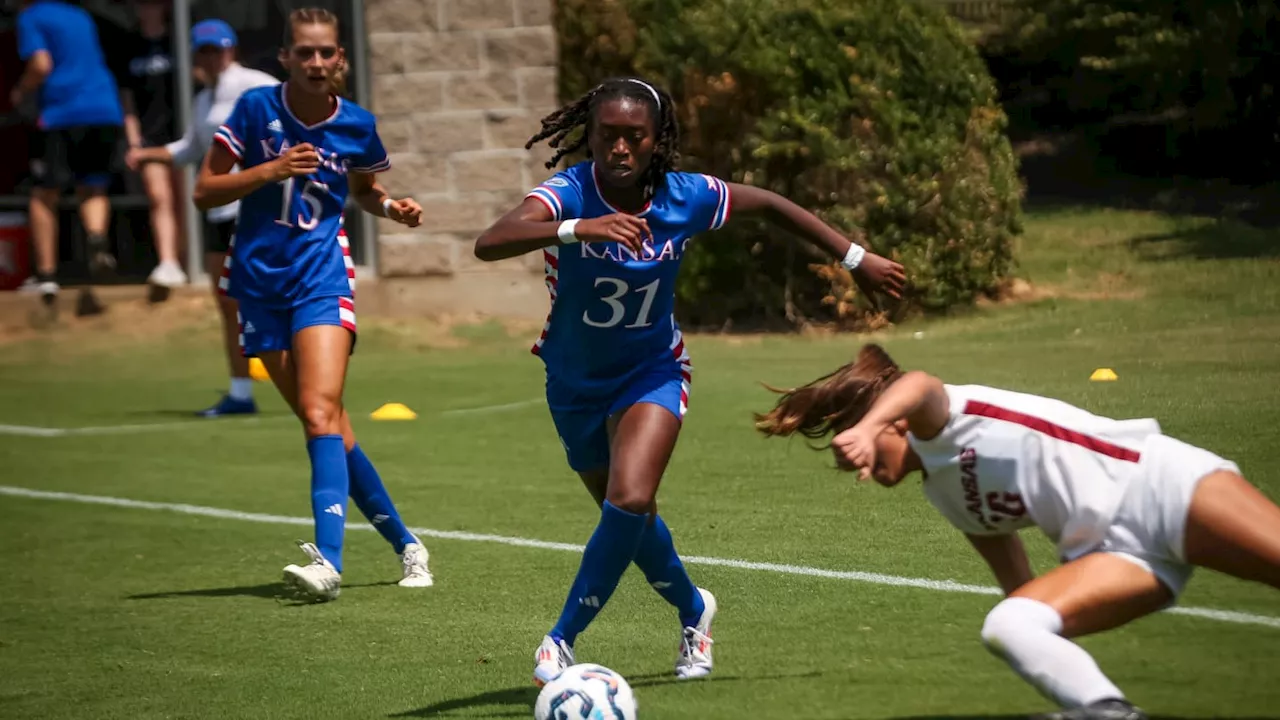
[529,161,730,394]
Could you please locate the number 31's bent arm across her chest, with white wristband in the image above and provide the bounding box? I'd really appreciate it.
[475,197,653,263]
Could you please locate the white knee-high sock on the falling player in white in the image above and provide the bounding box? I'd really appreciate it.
[982,597,1124,708]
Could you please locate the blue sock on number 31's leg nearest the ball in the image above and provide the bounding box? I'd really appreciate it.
[550,501,649,646]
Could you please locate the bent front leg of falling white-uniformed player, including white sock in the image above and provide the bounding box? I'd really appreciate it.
[982,552,1172,720]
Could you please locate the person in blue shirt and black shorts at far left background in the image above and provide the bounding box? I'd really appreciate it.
[10,0,124,318]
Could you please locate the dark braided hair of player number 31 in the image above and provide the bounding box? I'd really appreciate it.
[525,77,680,200]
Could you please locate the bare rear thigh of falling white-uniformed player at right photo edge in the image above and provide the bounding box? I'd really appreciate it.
[1183,470,1280,588]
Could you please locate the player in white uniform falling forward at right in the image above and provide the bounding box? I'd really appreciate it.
[756,345,1280,720]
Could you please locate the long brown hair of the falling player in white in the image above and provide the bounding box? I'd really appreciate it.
[755,343,902,439]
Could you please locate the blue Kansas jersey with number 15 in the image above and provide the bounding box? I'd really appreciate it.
[214,83,390,307]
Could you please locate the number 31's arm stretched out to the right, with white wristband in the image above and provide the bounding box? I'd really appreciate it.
[727,183,906,297]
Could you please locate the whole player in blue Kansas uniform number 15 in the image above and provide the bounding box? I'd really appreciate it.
[195,8,433,601]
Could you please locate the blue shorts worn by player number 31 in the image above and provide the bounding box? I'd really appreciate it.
[547,363,691,473]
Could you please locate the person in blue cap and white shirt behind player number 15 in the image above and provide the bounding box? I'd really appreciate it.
[125,19,280,418]
